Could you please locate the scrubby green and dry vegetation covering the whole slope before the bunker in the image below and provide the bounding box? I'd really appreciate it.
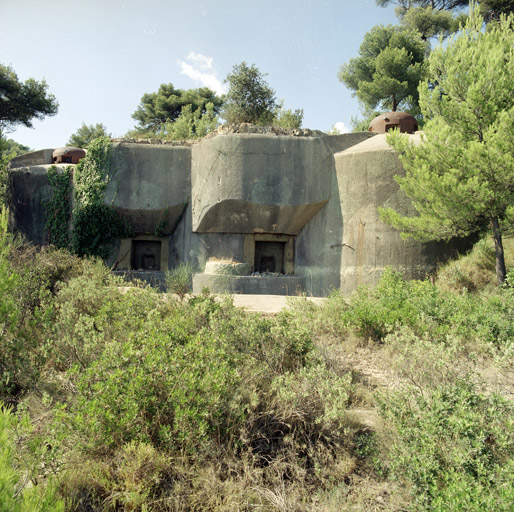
[0,214,514,512]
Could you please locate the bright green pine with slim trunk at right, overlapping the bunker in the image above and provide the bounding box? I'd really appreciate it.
[381,10,514,283]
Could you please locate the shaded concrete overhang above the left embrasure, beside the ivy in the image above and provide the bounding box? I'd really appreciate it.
[105,142,191,235]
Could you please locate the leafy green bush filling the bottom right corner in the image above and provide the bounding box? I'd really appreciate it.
[380,380,514,512]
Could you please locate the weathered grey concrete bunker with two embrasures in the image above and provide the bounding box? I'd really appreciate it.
[9,124,462,296]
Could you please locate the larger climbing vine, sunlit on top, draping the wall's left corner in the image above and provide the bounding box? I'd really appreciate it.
[71,137,128,258]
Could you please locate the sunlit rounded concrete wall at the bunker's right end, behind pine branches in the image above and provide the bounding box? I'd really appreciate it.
[335,134,456,293]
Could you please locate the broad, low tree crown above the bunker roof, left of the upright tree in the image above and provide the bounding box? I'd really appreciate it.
[132,83,223,133]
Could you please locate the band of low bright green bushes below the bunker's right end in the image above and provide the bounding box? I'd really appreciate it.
[316,268,514,351]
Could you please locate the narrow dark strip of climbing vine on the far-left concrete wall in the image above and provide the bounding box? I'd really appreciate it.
[43,166,72,249]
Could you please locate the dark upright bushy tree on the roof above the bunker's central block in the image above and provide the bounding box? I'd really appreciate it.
[223,62,277,124]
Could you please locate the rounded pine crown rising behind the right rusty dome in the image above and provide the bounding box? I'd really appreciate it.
[338,25,427,111]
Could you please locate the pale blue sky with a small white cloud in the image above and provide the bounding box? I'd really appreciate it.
[0,0,397,149]
